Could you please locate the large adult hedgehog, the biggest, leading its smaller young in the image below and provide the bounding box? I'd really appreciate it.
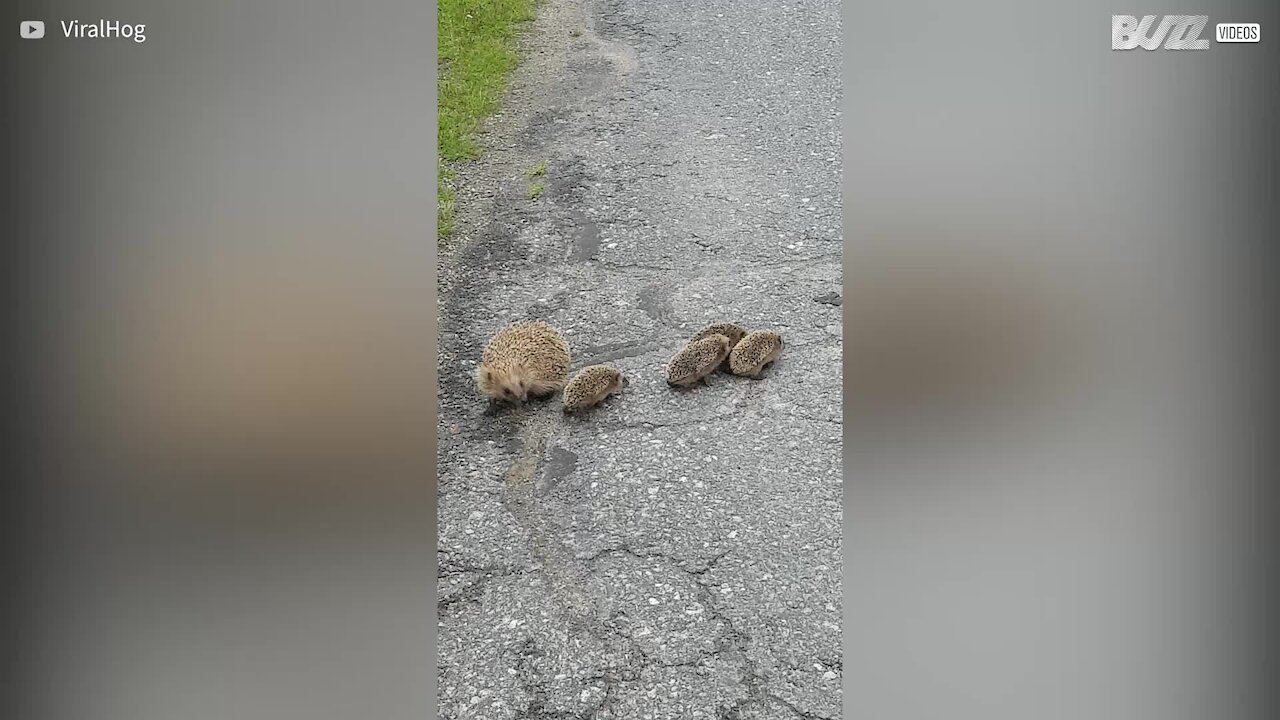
[476,320,570,402]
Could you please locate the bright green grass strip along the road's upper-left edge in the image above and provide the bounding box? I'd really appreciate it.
[436,0,538,237]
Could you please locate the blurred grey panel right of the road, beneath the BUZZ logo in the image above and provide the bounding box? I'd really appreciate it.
[845,0,1280,720]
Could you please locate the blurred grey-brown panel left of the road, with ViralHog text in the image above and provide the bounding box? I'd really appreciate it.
[4,0,435,720]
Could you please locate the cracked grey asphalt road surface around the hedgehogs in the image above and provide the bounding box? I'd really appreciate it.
[438,0,842,720]
